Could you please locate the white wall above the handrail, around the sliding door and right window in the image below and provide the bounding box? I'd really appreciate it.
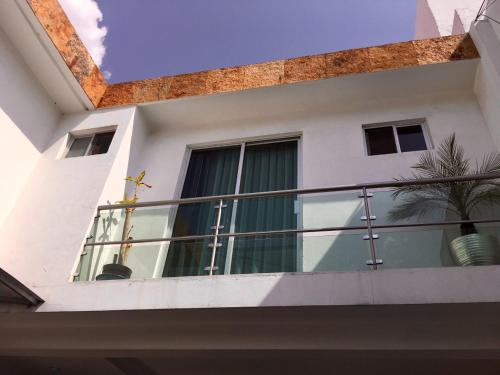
[141,93,495,200]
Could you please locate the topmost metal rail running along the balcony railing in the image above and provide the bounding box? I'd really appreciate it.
[97,173,500,211]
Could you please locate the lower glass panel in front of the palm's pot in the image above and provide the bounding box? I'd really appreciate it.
[375,224,500,269]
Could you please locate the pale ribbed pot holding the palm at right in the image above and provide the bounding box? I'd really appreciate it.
[450,234,500,266]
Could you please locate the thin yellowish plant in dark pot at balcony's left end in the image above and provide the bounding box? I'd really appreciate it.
[96,171,152,280]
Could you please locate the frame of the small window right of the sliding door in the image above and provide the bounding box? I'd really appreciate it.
[362,118,433,156]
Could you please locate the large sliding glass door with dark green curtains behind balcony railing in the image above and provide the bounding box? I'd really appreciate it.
[163,140,297,277]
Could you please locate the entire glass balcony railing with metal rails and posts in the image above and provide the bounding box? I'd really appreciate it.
[74,175,500,281]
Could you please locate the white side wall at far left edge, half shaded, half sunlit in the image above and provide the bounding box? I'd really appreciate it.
[0,28,60,228]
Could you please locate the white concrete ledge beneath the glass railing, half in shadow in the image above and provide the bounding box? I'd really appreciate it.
[30,266,500,311]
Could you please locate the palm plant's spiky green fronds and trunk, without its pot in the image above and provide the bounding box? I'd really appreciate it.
[388,134,500,235]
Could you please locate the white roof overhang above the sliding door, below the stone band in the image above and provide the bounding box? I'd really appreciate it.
[139,60,479,130]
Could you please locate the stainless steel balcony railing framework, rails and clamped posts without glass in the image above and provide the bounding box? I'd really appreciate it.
[75,173,500,277]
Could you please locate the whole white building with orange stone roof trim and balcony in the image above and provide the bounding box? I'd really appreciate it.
[0,0,500,374]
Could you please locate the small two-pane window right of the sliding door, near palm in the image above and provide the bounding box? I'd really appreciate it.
[364,119,428,155]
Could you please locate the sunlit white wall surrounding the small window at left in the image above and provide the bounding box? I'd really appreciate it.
[0,108,139,287]
